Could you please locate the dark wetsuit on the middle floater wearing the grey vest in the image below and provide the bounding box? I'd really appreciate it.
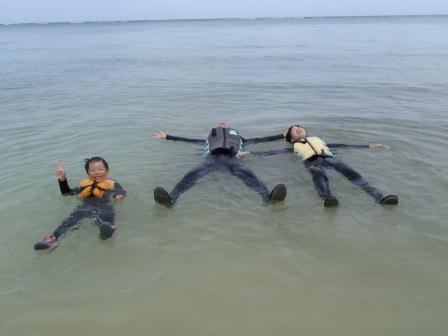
[166,134,284,203]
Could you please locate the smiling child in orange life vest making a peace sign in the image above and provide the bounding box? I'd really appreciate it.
[34,156,126,250]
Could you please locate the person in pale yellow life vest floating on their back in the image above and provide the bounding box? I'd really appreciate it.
[258,125,398,207]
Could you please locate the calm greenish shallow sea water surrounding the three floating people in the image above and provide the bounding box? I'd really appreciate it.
[0,16,448,336]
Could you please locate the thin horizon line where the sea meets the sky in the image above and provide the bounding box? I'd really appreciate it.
[0,14,448,26]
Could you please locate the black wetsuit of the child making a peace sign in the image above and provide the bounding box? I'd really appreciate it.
[53,179,126,238]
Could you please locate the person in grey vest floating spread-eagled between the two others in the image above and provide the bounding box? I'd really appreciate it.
[152,122,286,207]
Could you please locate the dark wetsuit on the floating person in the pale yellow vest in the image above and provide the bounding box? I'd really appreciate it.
[262,143,384,202]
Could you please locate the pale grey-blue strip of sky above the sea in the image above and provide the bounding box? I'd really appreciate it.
[0,0,448,24]
